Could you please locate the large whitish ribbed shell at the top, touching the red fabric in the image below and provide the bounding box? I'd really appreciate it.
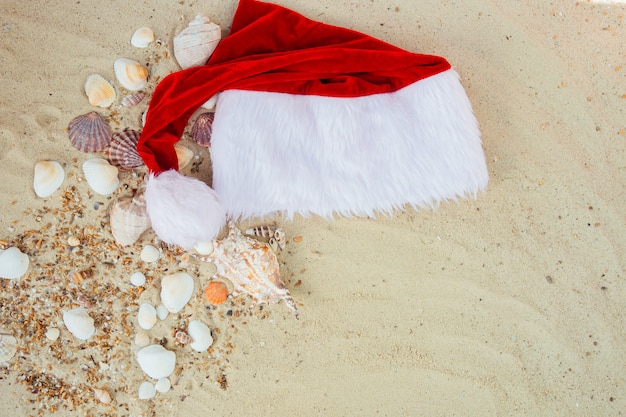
[174,14,222,69]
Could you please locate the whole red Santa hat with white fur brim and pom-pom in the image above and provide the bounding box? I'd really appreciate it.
[138,0,488,248]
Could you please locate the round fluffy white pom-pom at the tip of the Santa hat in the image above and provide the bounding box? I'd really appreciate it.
[144,170,226,249]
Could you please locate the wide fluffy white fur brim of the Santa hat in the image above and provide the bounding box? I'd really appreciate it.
[211,70,488,218]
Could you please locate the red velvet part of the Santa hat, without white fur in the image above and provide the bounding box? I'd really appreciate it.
[137,0,450,174]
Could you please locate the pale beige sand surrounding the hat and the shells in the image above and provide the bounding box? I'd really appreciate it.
[0,0,626,417]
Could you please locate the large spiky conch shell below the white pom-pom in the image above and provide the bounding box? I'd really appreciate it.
[198,222,298,318]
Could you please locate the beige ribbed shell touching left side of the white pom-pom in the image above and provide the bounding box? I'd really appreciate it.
[109,193,149,245]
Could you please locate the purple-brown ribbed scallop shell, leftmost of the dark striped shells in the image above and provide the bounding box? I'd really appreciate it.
[67,111,111,152]
